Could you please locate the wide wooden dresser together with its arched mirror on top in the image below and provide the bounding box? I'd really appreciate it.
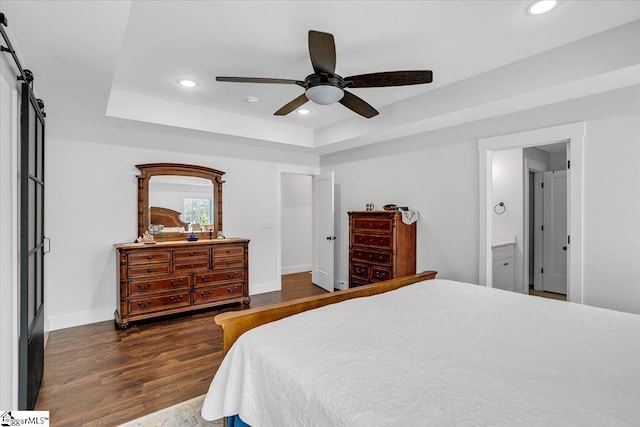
[114,163,251,328]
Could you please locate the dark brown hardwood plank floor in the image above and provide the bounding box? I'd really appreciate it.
[35,273,325,427]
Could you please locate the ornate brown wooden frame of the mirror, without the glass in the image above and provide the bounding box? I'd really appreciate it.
[136,163,224,240]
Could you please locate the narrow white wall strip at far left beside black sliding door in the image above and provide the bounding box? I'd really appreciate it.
[0,44,19,409]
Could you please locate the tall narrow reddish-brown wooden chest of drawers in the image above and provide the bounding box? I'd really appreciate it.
[349,211,416,288]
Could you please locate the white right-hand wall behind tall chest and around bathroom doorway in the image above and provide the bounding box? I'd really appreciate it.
[321,110,640,314]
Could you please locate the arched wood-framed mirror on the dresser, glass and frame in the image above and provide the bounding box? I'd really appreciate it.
[136,163,224,240]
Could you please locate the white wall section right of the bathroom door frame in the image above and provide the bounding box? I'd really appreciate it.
[584,111,640,313]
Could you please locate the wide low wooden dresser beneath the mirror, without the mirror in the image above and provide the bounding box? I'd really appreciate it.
[114,239,250,328]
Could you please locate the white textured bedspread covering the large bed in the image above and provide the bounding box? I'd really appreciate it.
[202,280,640,427]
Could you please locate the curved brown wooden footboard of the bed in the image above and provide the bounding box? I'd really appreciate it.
[214,271,437,354]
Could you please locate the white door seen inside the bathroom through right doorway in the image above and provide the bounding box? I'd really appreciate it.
[542,171,568,295]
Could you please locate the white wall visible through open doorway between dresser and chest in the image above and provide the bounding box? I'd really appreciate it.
[281,173,312,274]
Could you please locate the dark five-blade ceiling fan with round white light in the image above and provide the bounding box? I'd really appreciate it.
[216,30,433,119]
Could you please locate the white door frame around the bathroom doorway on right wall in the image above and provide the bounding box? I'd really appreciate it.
[478,122,585,304]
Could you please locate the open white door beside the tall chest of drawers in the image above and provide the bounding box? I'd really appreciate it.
[311,172,336,292]
